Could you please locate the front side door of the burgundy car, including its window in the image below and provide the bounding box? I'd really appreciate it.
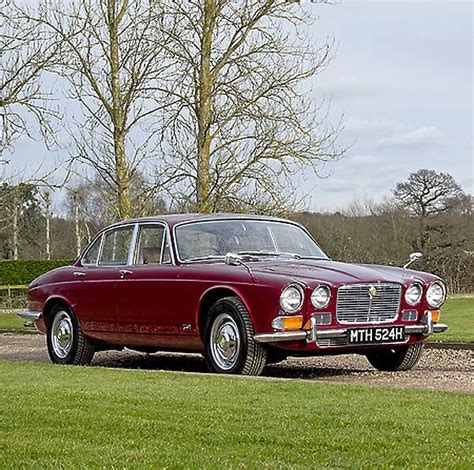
[117,223,197,348]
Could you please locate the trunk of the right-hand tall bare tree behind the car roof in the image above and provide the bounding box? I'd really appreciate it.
[197,0,217,213]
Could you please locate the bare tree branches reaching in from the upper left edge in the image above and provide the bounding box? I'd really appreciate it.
[0,0,60,162]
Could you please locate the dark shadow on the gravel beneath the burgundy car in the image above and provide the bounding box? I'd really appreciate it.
[92,351,371,379]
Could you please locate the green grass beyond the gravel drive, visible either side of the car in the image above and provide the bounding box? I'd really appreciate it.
[0,298,474,342]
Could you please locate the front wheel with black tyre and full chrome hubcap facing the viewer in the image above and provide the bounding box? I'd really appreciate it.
[204,297,267,375]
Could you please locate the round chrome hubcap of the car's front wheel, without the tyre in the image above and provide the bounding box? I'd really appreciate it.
[211,313,240,370]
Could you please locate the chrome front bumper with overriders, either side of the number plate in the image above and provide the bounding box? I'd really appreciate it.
[254,314,448,343]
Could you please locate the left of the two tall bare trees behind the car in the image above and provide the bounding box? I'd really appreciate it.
[25,0,172,219]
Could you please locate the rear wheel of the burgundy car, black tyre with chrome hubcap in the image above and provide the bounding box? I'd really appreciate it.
[46,304,95,366]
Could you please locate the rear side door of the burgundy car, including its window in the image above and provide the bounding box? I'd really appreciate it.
[72,225,135,342]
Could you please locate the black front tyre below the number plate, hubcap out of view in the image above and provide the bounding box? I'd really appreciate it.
[367,341,425,372]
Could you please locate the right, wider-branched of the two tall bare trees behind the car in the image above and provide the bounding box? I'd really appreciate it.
[164,0,339,212]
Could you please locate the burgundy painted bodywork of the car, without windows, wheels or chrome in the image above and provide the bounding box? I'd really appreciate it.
[28,214,439,354]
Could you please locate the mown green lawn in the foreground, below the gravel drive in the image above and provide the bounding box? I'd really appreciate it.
[0,362,474,469]
